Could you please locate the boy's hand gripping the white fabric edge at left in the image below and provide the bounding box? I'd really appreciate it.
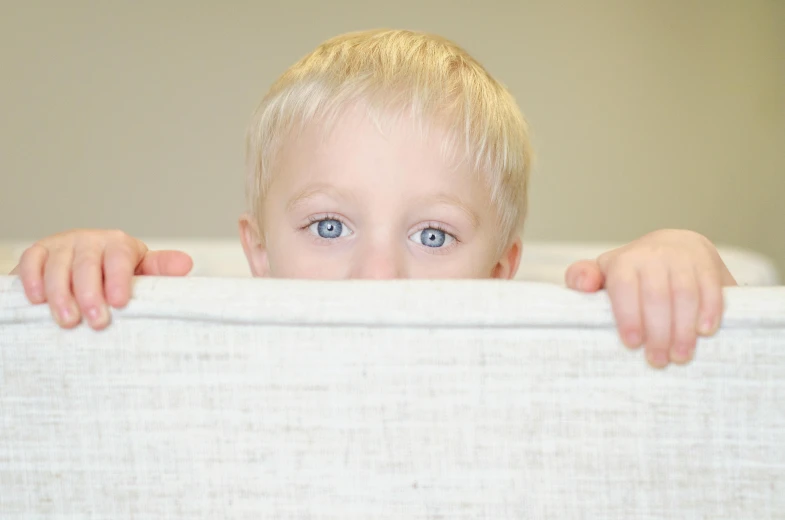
[11,230,193,330]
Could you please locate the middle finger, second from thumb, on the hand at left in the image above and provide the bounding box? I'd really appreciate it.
[73,241,109,330]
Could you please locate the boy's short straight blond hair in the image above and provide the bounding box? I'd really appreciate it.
[246,29,533,247]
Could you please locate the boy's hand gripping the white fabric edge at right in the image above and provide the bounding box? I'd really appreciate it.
[565,230,736,368]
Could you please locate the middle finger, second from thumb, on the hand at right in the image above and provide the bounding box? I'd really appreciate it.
[640,265,672,368]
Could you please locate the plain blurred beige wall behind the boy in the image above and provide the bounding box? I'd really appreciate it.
[0,0,785,270]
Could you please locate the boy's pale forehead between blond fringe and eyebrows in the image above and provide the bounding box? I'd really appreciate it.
[272,113,489,206]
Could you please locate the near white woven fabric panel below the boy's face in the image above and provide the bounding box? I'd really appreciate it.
[0,277,785,520]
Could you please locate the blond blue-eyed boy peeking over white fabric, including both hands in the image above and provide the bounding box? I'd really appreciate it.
[14,30,735,367]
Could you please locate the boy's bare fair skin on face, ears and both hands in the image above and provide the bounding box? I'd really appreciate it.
[12,111,735,367]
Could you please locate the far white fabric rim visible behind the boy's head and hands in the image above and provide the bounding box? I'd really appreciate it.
[0,238,781,286]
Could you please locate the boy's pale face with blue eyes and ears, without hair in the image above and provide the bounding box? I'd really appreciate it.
[240,109,521,279]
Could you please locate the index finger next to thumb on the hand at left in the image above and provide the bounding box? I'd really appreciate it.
[104,238,147,308]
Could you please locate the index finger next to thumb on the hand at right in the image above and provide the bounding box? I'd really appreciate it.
[605,268,644,348]
